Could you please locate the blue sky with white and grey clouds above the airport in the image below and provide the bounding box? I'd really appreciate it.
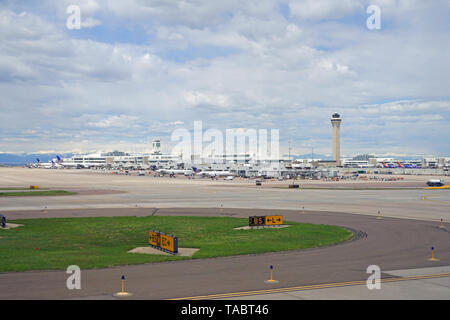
[0,0,450,156]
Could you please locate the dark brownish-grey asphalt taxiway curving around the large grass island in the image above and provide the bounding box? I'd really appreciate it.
[0,208,450,299]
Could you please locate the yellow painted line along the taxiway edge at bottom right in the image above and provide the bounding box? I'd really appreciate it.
[167,272,450,300]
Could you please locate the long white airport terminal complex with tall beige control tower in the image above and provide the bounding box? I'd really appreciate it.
[51,119,450,178]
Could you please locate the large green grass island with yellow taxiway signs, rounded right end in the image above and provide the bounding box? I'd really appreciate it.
[0,216,353,271]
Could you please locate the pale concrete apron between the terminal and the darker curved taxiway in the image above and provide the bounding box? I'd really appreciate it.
[0,168,450,221]
